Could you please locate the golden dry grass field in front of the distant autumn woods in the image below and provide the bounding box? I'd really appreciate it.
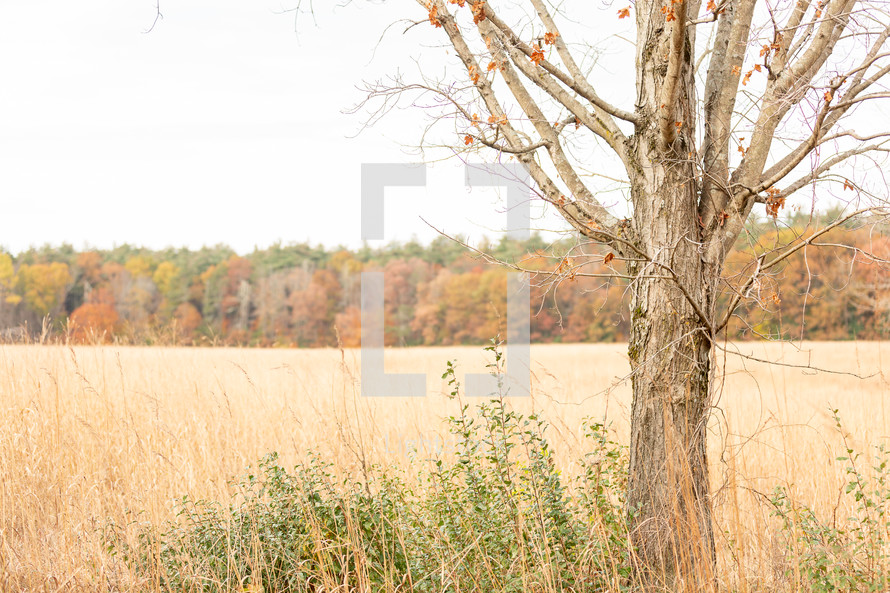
[0,343,890,592]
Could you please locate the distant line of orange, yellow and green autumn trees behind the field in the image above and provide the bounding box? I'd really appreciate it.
[0,214,890,347]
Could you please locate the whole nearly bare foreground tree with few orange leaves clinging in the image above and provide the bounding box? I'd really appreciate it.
[346,0,890,591]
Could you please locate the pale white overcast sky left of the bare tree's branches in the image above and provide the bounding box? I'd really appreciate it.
[0,0,584,252]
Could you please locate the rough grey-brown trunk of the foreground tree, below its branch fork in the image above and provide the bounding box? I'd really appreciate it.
[628,156,716,592]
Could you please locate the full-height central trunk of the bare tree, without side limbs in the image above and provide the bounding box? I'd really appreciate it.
[628,0,720,592]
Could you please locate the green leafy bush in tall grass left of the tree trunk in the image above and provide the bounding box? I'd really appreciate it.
[109,355,629,593]
